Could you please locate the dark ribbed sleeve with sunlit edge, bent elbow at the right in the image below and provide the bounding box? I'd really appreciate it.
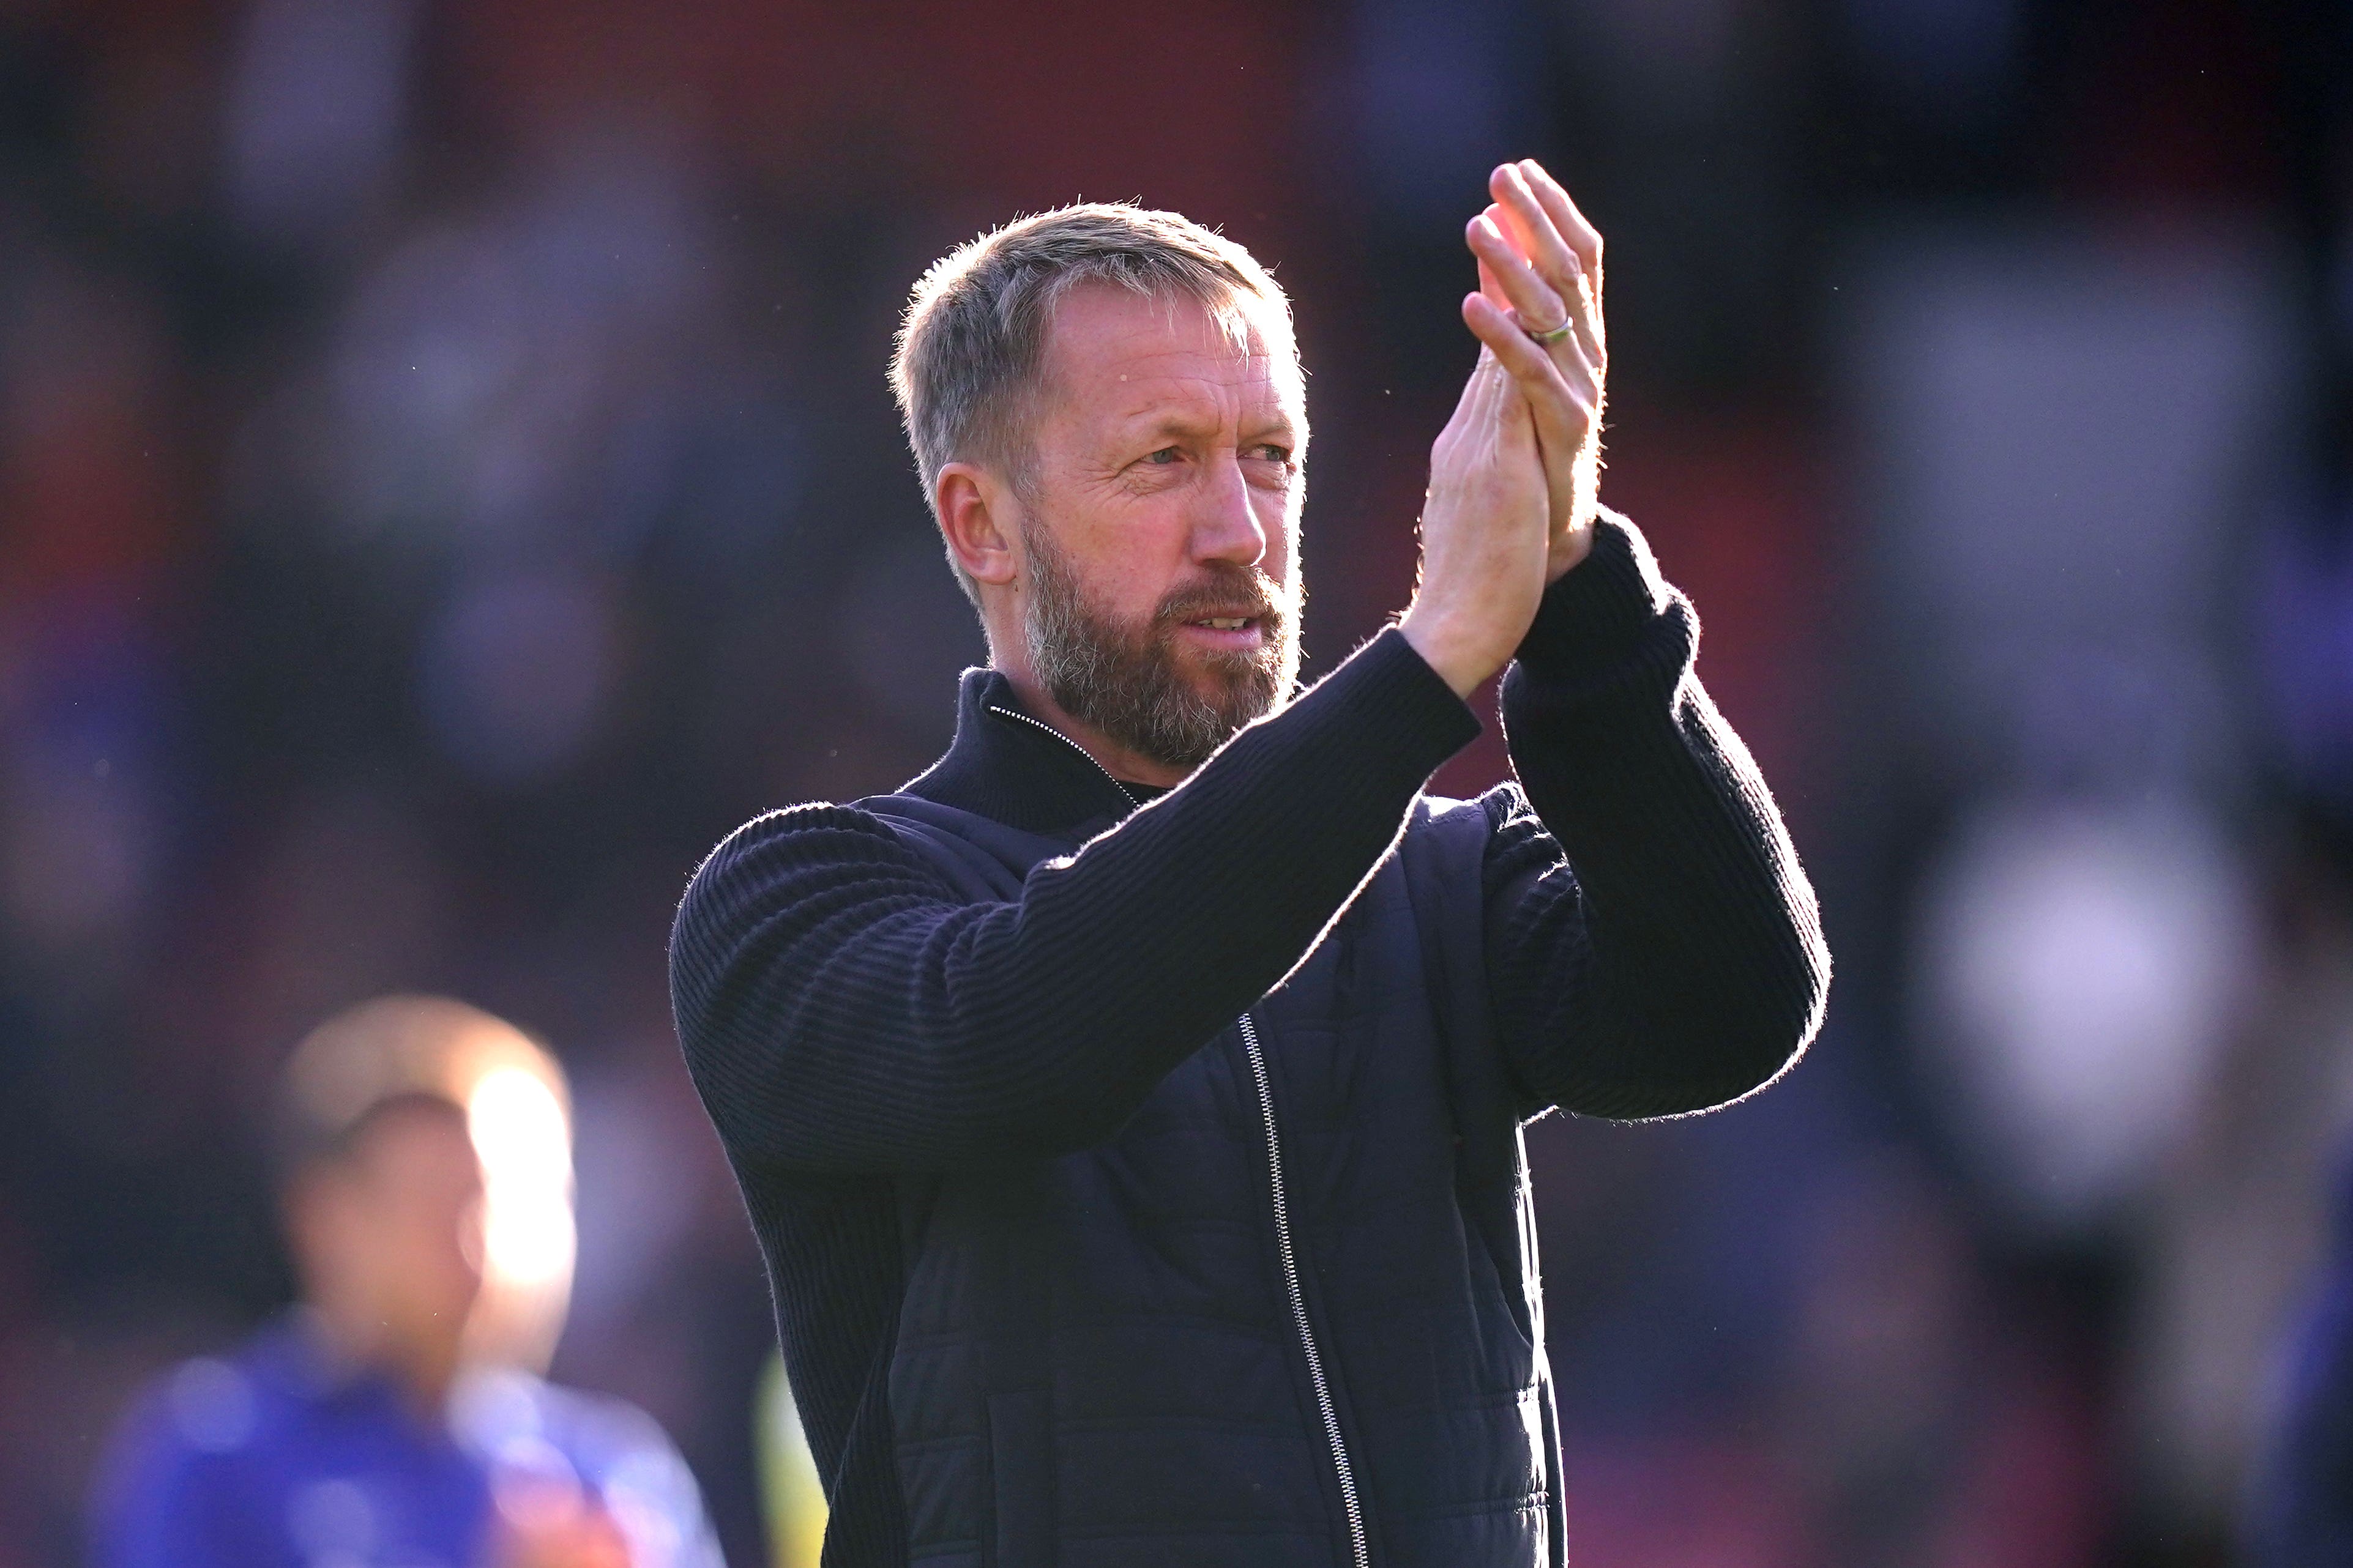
[1485,513,1830,1119]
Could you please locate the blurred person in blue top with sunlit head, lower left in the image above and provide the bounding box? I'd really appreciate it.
[92,997,720,1568]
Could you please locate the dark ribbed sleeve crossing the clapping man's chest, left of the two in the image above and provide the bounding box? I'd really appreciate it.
[671,630,1478,1173]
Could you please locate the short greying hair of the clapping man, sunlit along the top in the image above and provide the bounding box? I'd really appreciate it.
[889,202,1299,604]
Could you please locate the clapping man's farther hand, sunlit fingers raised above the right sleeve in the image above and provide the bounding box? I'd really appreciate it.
[1471,157,1609,583]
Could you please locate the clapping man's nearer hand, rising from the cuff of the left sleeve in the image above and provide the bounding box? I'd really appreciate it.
[1398,188,1586,696]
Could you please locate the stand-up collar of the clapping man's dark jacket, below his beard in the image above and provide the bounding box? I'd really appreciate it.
[899,670,1136,837]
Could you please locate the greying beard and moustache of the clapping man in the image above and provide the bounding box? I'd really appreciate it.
[1021,527,1299,769]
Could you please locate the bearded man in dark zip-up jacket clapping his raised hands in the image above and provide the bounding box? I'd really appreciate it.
[671,162,1829,1568]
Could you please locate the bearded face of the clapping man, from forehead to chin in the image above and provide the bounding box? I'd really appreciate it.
[1021,284,1306,767]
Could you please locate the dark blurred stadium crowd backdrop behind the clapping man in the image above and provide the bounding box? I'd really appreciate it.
[0,0,2353,1568]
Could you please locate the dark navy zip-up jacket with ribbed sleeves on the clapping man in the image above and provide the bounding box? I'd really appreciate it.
[671,517,1829,1568]
